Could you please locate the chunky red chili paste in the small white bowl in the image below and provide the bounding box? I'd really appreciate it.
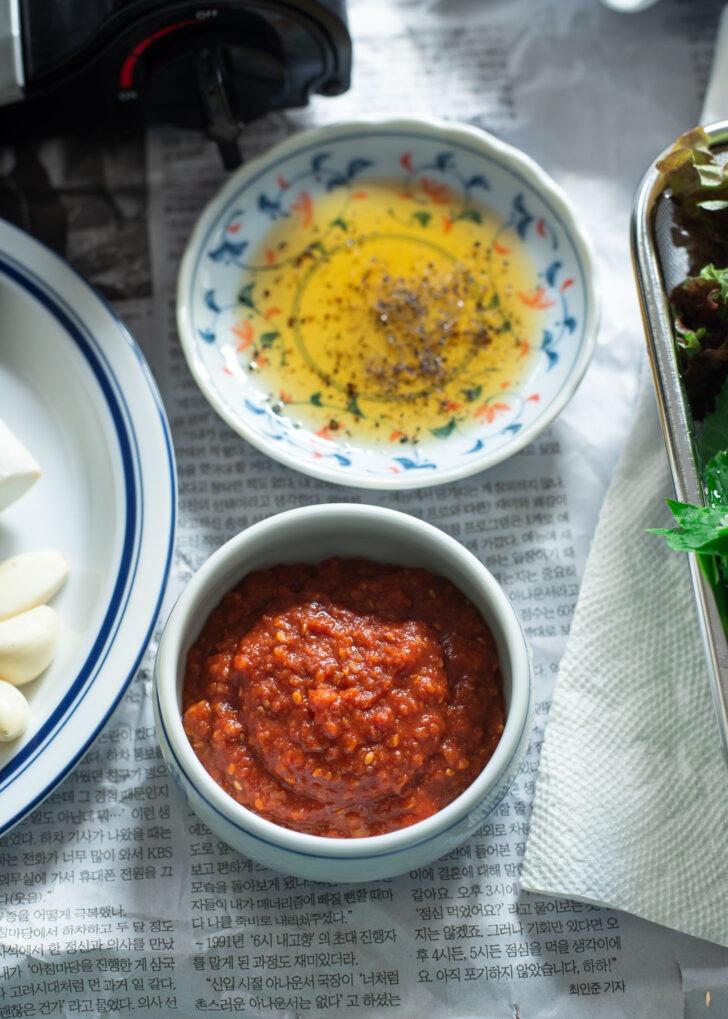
[184,558,505,838]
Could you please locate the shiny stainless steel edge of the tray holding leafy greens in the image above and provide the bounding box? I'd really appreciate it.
[630,121,728,763]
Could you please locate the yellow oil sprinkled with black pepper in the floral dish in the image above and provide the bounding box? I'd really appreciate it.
[242,181,540,442]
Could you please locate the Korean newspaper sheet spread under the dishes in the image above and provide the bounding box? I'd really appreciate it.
[0,0,728,1019]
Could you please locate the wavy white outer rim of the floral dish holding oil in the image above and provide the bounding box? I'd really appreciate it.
[175,116,602,491]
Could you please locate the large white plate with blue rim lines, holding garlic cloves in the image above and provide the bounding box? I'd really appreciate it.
[0,215,176,833]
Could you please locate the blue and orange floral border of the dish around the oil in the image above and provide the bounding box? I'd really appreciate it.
[179,121,597,487]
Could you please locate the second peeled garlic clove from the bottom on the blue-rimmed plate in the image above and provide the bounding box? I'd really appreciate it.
[0,605,60,687]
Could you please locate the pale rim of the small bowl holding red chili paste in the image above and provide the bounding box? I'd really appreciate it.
[153,503,534,861]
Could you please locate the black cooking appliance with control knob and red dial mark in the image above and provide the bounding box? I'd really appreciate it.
[0,0,352,167]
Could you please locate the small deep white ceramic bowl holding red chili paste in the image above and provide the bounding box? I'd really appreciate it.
[154,504,533,881]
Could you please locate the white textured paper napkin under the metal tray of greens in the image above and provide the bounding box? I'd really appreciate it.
[521,379,728,946]
